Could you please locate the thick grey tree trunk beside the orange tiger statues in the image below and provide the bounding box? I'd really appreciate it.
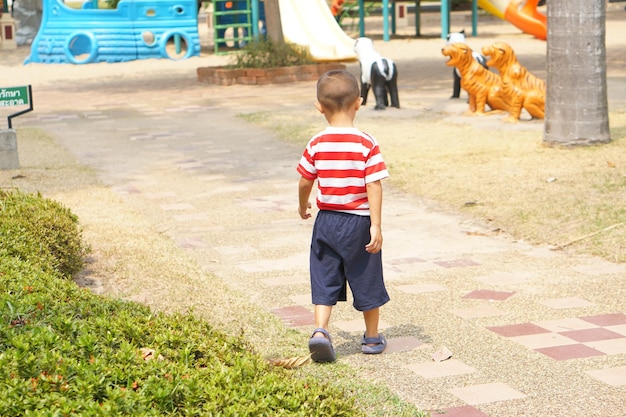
[543,0,611,146]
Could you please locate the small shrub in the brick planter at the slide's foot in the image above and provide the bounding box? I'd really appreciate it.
[229,38,315,68]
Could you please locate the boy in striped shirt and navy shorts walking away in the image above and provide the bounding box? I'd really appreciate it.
[297,70,389,362]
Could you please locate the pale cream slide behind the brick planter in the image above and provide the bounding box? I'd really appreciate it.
[278,0,357,61]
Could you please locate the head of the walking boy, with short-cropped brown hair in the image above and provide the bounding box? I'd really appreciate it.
[317,70,361,113]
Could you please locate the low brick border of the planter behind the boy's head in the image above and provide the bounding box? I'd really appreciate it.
[196,62,346,85]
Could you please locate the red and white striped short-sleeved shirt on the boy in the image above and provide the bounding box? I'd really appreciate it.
[297,127,389,216]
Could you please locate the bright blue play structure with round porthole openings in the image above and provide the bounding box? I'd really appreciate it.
[24,0,200,64]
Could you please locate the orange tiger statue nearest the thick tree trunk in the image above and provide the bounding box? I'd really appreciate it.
[482,42,546,122]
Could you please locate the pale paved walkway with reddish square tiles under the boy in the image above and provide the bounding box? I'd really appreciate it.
[3,5,626,417]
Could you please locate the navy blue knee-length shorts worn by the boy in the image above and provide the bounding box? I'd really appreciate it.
[310,210,389,311]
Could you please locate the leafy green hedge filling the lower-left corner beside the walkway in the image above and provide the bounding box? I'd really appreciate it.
[0,194,362,416]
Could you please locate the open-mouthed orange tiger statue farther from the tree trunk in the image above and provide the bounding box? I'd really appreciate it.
[441,43,509,115]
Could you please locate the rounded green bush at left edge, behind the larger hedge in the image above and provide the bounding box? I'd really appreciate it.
[0,190,88,276]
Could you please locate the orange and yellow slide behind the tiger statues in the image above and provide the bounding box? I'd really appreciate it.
[478,0,547,40]
